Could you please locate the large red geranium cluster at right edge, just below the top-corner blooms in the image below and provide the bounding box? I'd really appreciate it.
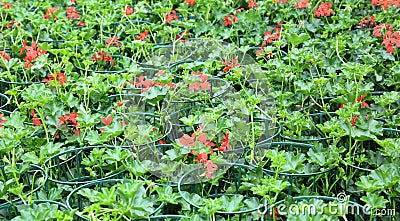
[374,24,400,53]
